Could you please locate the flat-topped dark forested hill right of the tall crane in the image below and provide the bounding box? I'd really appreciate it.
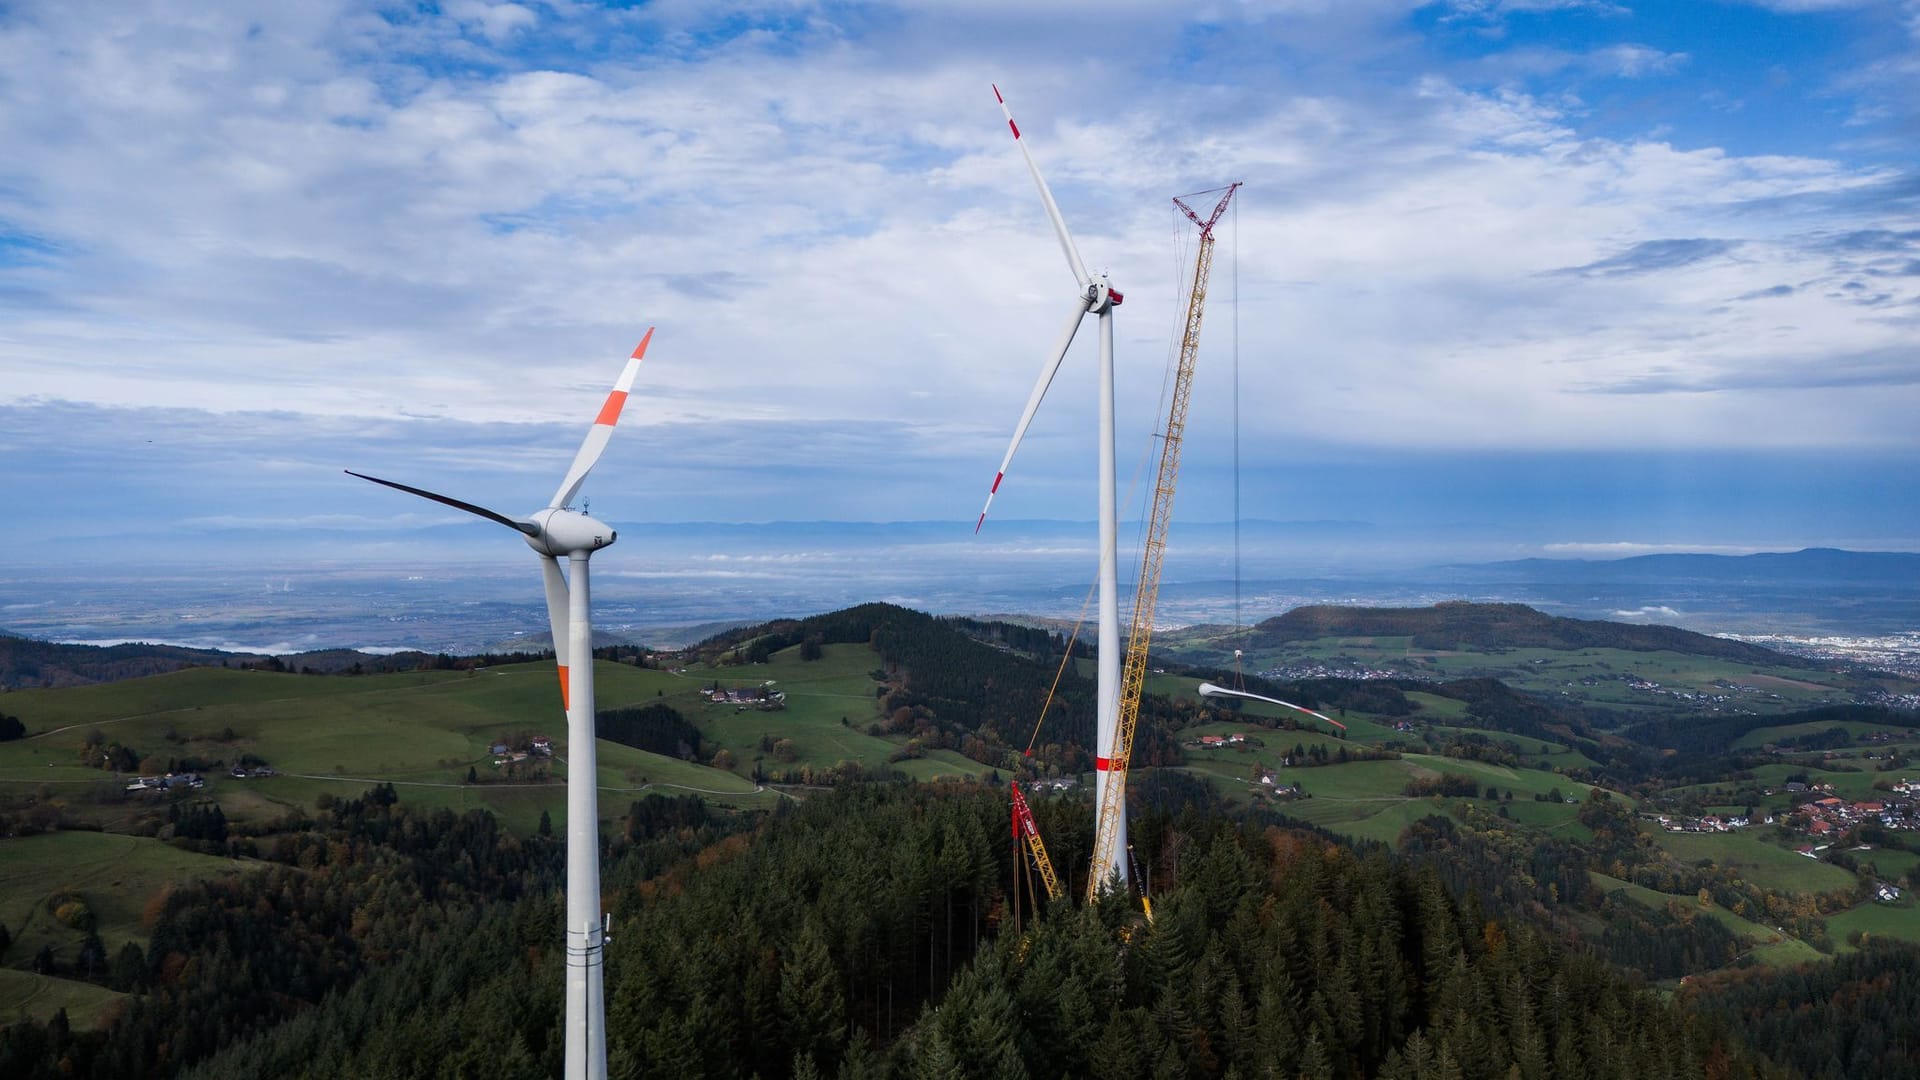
[1254,600,1809,667]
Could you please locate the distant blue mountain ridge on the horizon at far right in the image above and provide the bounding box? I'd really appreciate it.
[1448,548,1920,588]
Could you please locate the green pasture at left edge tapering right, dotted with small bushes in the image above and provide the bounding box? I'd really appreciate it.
[0,832,261,967]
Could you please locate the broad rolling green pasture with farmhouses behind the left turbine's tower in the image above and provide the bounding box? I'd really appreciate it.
[0,661,783,830]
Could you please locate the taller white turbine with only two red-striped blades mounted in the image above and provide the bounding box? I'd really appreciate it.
[973,86,1129,892]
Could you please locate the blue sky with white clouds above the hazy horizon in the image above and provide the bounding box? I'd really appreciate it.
[0,0,1920,592]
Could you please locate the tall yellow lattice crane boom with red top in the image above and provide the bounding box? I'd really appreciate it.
[1087,183,1240,901]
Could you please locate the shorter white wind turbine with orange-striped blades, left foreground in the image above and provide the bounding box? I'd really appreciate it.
[346,327,653,1080]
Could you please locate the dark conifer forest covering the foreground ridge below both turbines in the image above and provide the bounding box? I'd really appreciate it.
[0,772,1797,1078]
